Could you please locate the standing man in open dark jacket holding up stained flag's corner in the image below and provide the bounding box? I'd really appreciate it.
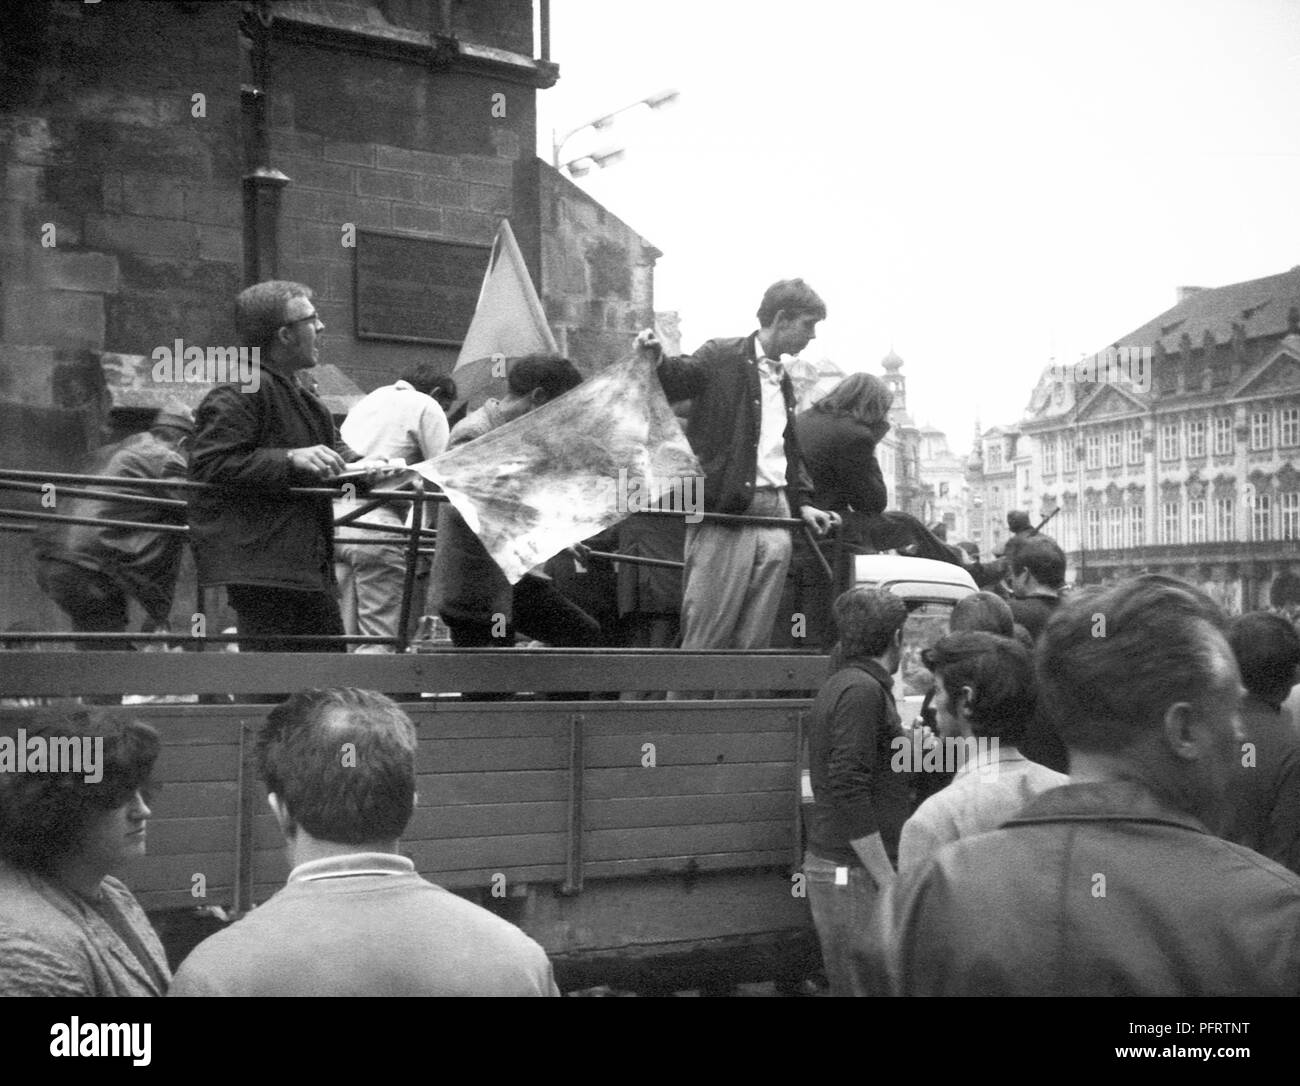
[637,280,833,658]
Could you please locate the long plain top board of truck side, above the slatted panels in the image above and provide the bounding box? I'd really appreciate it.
[5,649,826,697]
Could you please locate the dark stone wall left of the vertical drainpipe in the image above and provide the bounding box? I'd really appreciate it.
[0,4,242,628]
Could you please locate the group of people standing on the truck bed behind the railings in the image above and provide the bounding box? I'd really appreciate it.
[38,271,998,663]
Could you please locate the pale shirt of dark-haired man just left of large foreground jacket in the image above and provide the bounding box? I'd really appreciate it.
[898,743,1070,874]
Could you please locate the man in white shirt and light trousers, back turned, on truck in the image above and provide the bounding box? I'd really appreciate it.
[334,363,447,653]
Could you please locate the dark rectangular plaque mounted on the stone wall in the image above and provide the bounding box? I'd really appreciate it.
[355,230,491,346]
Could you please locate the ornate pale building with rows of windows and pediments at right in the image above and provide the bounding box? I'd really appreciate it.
[972,267,1300,611]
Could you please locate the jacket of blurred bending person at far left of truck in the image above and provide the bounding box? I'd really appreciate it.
[36,433,186,622]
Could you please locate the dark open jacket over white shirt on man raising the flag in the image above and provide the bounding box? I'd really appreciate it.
[659,334,813,516]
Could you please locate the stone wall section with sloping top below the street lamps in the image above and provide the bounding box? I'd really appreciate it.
[540,163,659,375]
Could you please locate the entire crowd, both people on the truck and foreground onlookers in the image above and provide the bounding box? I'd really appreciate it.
[10,280,1300,995]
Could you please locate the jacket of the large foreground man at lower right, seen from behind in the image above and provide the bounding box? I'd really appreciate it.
[861,782,1300,996]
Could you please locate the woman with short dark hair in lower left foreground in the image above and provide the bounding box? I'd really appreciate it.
[0,711,172,996]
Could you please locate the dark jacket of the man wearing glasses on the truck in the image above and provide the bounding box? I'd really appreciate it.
[190,365,359,592]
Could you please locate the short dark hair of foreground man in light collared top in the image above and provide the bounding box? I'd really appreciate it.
[257,687,416,844]
